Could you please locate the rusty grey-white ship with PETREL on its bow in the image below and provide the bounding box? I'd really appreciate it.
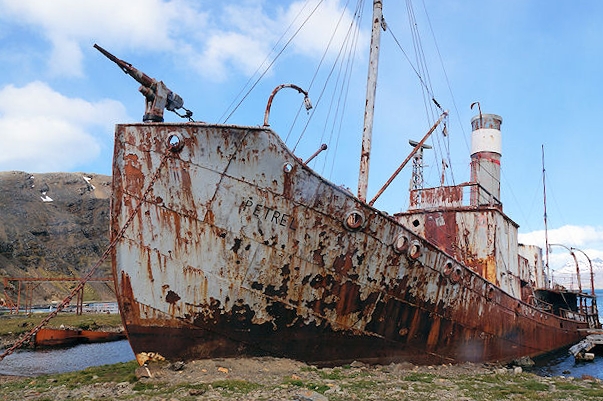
[97,0,599,365]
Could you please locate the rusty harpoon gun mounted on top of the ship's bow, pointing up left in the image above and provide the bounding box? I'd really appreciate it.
[94,44,193,123]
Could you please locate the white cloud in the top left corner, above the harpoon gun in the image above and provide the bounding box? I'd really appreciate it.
[0,0,201,76]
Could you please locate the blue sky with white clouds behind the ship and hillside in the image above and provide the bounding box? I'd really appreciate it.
[0,0,603,280]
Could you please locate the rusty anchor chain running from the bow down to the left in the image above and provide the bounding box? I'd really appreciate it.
[0,148,172,361]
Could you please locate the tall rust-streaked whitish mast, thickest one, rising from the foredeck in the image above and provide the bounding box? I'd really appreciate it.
[358,0,383,202]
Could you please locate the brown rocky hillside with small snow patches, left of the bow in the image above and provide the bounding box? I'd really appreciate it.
[0,171,114,302]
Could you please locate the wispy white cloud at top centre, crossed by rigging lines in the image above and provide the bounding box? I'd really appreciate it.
[188,0,367,80]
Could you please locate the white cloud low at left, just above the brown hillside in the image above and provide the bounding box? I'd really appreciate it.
[0,82,125,172]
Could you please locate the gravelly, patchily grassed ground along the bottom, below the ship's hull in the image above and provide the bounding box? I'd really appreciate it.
[0,358,603,401]
